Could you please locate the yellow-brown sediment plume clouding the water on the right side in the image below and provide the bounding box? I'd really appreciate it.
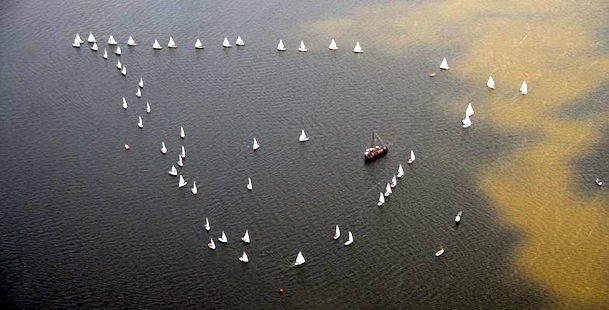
[308,0,609,309]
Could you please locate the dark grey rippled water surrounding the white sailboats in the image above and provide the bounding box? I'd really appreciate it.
[0,0,609,309]
